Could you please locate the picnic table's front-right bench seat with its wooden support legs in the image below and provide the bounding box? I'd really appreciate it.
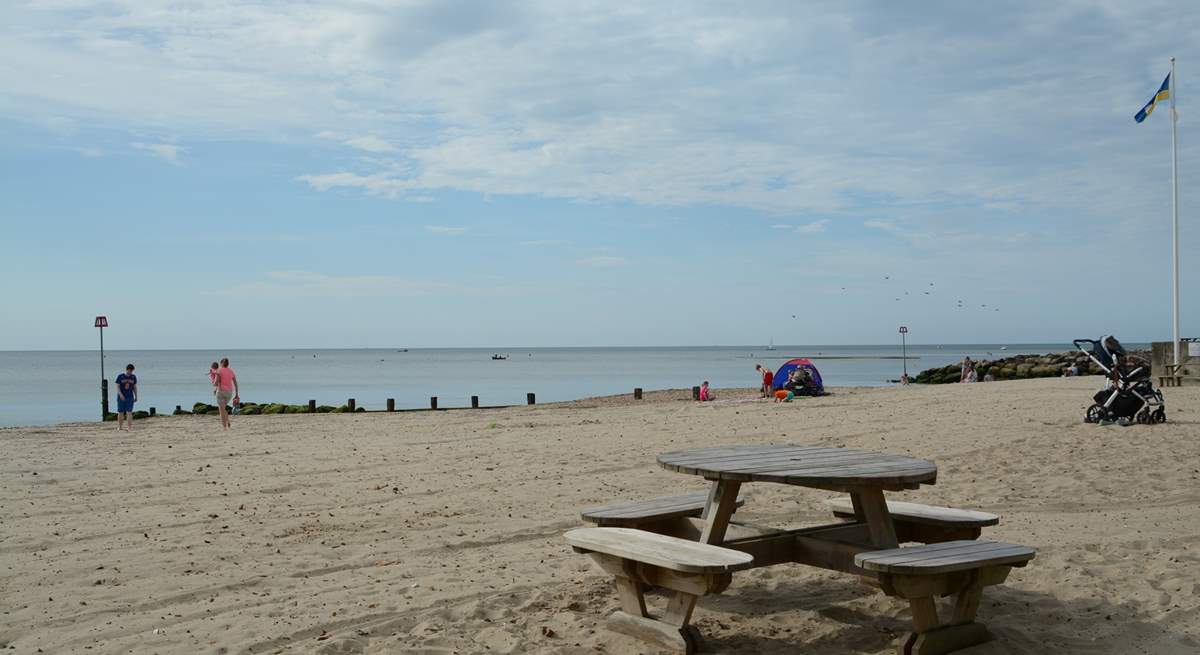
[854,540,1037,655]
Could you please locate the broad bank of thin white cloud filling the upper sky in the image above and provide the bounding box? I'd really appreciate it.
[0,0,1200,221]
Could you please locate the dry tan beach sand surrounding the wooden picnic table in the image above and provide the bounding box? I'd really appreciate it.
[0,378,1200,655]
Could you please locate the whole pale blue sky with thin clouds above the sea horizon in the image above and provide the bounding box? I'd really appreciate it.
[0,0,1200,349]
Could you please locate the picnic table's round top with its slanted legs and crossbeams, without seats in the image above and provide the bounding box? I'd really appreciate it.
[658,445,937,577]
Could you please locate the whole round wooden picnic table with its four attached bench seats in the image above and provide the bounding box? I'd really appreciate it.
[565,445,1036,655]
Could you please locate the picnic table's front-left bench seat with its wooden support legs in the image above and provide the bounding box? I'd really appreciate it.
[563,528,754,654]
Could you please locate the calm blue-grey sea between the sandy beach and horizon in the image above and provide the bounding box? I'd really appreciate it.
[0,343,1099,426]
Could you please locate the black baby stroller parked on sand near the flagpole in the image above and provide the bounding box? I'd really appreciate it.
[1073,336,1166,425]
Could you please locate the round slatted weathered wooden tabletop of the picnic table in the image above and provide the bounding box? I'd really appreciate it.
[658,445,937,489]
